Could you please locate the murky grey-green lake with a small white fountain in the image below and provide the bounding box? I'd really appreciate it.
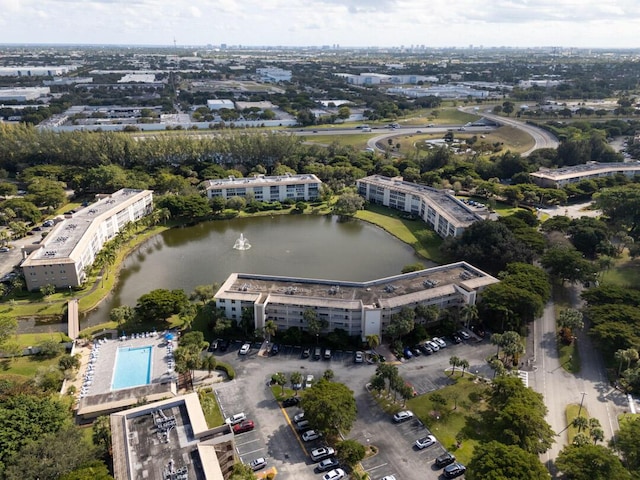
[82,215,433,328]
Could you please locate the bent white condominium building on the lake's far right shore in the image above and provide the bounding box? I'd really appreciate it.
[357,175,489,238]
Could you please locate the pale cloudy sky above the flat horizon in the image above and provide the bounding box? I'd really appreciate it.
[0,0,640,48]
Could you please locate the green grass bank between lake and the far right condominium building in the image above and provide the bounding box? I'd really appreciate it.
[356,204,443,263]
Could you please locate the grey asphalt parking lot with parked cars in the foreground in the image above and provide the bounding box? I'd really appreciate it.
[210,339,495,480]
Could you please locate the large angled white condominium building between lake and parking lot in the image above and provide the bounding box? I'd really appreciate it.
[215,262,499,339]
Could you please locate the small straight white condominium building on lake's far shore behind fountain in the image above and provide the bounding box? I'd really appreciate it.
[206,174,322,202]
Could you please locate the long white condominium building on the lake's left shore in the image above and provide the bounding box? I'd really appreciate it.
[21,188,153,290]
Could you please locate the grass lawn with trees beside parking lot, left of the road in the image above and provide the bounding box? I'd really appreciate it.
[407,374,488,463]
